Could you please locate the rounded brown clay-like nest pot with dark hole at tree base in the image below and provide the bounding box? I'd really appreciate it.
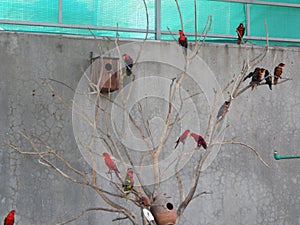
[150,194,177,225]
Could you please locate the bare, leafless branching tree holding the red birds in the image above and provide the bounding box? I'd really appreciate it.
[5,0,285,224]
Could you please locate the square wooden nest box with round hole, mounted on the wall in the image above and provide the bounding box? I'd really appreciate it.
[91,53,119,93]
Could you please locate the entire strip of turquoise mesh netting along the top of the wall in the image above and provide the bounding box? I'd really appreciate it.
[0,0,300,45]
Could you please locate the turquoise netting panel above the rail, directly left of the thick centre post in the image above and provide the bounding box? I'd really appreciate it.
[62,0,155,29]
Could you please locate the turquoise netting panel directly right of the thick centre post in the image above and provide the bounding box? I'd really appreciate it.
[161,0,246,35]
